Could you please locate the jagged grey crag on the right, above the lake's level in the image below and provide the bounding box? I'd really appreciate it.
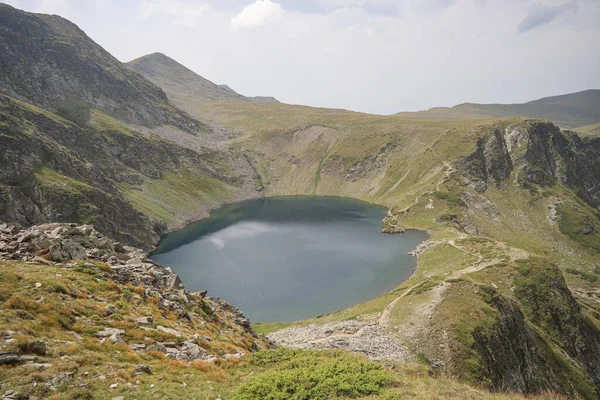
[460,121,600,210]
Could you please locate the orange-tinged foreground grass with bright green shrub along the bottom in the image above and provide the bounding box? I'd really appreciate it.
[0,262,568,400]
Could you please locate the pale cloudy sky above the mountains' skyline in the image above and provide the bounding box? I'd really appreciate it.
[0,0,600,114]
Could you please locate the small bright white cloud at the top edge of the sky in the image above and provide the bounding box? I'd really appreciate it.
[137,0,210,27]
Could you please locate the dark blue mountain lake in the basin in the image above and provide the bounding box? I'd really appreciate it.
[152,196,427,322]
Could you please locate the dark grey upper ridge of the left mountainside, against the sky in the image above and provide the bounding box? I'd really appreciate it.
[0,4,200,134]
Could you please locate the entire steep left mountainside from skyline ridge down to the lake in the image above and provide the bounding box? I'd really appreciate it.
[0,5,264,248]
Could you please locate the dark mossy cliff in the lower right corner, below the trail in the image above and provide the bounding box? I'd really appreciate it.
[471,258,600,399]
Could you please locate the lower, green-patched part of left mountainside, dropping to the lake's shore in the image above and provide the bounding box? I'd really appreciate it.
[0,96,251,248]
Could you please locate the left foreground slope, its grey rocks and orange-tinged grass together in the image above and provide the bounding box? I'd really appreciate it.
[0,224,270,398]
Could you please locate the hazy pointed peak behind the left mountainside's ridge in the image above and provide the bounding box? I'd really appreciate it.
[125,53,278,110]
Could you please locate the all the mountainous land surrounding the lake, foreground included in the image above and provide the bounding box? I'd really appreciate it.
[0,4,600,399]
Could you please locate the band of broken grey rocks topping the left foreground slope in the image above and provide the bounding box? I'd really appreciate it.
[0,224,256,340]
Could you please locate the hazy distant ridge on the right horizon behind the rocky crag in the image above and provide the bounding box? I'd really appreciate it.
[396,90,600,128]
